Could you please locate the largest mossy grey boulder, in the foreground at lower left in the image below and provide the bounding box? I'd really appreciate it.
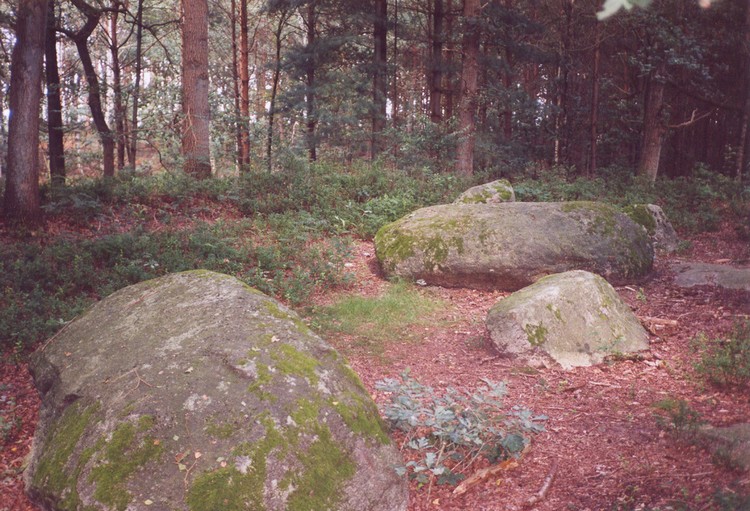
[26,271,407,511]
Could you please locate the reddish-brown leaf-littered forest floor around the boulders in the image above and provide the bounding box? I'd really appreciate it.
[0,217,750,511]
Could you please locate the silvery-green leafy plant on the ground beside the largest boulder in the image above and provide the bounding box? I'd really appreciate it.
[375,372,547,484]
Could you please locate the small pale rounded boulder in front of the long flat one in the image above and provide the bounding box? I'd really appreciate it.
[487,270,648,369]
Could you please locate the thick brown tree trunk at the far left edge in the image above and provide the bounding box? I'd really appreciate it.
[3,0,47,229]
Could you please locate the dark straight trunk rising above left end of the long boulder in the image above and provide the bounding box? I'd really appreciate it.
[370,0,388,159]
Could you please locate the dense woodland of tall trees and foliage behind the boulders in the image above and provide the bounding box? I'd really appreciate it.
[0,0,750,227]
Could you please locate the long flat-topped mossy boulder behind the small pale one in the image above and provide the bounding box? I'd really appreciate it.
[375,202,654,291]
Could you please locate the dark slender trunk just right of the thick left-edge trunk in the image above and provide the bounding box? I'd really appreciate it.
[44,0,65,187]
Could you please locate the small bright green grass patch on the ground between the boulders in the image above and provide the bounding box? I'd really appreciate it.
[310,282,446,354]
